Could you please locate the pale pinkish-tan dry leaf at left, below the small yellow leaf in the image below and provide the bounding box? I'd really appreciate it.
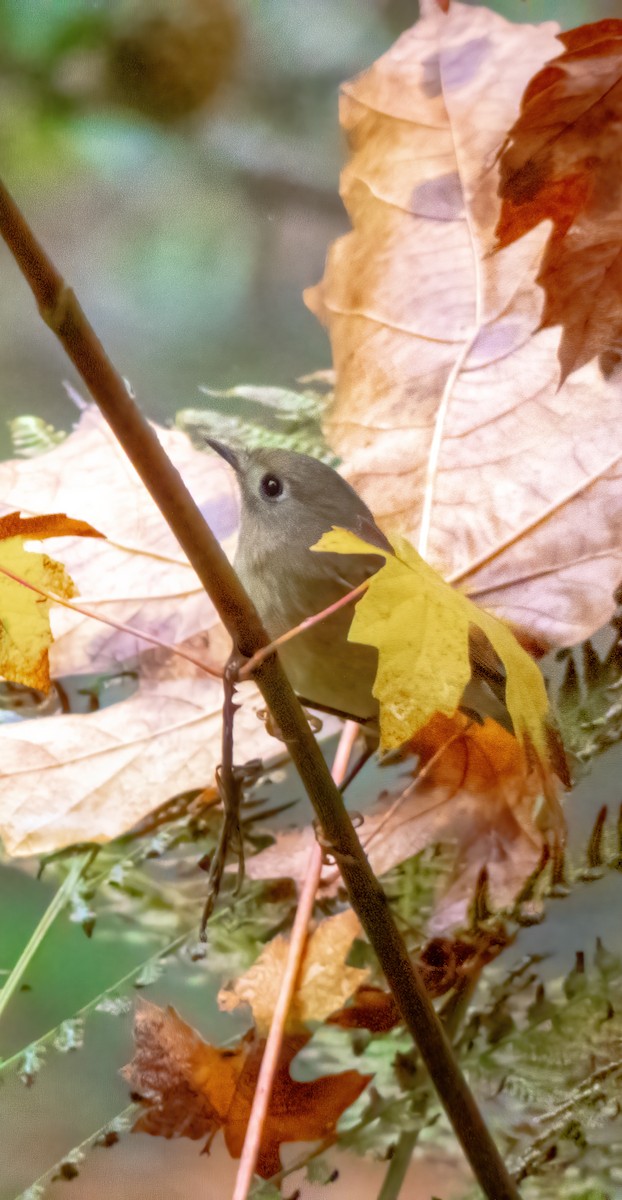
[0,652,279,854]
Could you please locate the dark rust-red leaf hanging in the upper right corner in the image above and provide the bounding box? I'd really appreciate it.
[496,19,622,383]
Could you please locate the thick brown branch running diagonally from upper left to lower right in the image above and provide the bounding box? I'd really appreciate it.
[0,175,519,1200]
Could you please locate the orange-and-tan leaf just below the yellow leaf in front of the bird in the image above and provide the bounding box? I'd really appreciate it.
[361,713,566,932]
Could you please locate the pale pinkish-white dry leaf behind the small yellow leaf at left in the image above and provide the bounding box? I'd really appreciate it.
[0,407,238,676]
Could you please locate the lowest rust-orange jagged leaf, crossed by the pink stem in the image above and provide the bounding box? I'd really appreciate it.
[122,1001,371,1180]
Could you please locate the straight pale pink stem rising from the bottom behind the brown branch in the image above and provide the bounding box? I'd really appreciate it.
[232,721,359,1200]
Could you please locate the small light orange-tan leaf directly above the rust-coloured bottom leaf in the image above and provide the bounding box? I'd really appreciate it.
[219,907,369,1036]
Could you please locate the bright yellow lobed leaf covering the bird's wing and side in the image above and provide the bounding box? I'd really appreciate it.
[311,526,549,758]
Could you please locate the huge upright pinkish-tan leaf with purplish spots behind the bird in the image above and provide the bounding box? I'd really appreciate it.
[306,0,622,644]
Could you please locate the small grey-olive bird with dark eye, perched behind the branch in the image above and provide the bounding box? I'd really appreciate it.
[209,440,512,730]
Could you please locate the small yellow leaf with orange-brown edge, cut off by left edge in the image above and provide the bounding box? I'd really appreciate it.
[0,512,102,691]
